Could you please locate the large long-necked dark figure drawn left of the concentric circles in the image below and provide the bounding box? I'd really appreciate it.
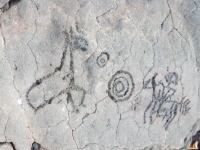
[26,26,88,112]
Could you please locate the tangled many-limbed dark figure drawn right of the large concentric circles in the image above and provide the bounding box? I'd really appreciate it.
[143,72,190,130]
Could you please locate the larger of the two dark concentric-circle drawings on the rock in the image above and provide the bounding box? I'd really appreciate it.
[108,70,135,102]
